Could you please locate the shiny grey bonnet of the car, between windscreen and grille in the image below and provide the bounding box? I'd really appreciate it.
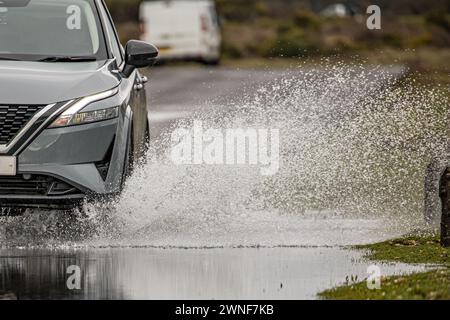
[0,61,120,105]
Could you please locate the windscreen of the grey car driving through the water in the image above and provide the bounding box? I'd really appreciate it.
[0,0,107,60]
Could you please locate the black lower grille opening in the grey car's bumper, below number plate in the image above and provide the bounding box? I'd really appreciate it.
[0,175,81,196]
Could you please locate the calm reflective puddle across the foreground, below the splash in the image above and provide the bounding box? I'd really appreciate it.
[0,248,424,299]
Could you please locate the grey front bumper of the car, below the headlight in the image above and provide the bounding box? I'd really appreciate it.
[0,117,128,209]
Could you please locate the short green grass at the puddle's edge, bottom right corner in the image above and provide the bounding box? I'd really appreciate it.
[319,236,450,300]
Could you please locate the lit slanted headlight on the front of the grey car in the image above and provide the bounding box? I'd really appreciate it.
[49,88,119,128]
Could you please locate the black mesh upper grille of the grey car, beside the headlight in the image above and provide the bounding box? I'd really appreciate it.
[0,105,45,145]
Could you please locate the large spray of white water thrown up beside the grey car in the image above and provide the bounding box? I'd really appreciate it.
[3,63,449,247]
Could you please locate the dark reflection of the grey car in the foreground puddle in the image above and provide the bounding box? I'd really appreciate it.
[0,249,123,299]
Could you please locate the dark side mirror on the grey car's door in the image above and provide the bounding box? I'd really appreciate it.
[123,40,158,77]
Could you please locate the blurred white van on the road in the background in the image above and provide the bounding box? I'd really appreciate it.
[140,0,221,64]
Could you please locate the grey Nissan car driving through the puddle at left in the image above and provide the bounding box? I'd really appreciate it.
[0,0,158,209]
